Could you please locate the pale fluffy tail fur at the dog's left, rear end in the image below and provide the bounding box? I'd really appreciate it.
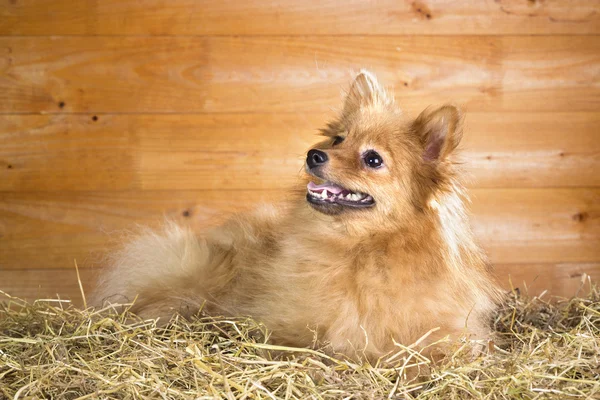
[92,222,224,323]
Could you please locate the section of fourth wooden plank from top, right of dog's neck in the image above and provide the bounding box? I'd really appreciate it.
[470,188,600,263]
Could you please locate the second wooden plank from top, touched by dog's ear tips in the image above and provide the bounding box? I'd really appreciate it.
[0,36,600,113]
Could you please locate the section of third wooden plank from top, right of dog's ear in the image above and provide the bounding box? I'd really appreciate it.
[460,112,600,188]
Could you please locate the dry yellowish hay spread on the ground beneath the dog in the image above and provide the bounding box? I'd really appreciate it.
[0,282,600,399]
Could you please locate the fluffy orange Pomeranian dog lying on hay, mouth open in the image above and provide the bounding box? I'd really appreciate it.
[94,70,500,360]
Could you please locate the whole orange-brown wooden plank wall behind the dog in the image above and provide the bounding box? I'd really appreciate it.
[0,0,600,299]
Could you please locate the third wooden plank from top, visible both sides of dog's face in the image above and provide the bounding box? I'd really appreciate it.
[0,113,600,191]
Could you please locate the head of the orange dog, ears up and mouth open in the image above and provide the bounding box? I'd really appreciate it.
[306,71,462,230]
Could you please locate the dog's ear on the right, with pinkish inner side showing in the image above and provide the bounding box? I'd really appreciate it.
[413,105,462,162]
